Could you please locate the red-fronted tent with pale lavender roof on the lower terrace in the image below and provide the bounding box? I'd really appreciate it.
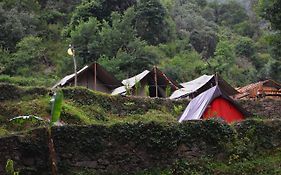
[179,86,250,123]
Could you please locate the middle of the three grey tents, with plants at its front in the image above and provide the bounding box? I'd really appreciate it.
[112,67,179,98]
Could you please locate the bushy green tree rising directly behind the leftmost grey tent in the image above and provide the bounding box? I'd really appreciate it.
[71,8,136,63]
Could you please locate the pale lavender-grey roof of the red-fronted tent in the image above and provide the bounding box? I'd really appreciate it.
[179,86,250,122]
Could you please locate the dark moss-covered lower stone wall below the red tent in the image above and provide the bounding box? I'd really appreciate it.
[0,120,281,174]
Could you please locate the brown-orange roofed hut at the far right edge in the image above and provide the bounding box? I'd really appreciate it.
[235,79,281,99]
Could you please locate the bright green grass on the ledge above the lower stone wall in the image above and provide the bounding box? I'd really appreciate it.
[0,88,176,132]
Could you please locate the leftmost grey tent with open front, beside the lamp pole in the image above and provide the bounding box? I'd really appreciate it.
[53,63,122,94]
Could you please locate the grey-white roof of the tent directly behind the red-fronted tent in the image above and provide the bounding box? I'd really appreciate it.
[170,75,238,99]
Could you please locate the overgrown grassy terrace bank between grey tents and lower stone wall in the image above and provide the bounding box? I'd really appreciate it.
[0,84,187,135]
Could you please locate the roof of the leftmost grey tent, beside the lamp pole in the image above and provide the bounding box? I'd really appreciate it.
[52,63,121,89]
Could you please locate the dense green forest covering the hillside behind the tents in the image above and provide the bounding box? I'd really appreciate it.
[0,0,281,86]
